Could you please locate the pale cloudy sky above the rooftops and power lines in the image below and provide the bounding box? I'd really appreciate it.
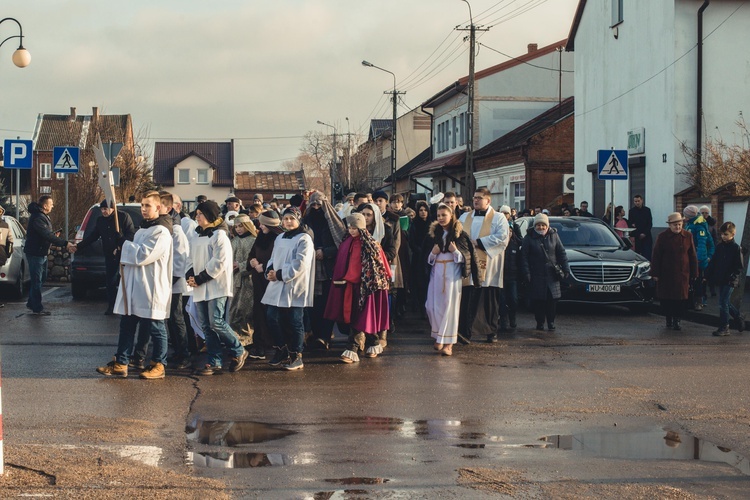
[0,0,578,171]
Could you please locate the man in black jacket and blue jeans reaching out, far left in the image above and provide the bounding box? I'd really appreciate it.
[23,194,76,316]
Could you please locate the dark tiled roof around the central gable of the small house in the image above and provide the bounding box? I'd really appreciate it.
[154,141,234,187]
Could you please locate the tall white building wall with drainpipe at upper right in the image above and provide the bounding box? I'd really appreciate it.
[566,0,750,226]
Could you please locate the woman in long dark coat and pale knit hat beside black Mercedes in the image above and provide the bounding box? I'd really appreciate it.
[521,214,570,331]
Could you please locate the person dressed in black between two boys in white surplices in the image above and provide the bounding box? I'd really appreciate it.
[247,210,282,359]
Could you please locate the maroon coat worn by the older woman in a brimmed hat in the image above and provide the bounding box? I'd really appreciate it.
[651,229,698,300]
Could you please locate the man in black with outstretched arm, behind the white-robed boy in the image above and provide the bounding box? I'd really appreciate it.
[76,200,135,315]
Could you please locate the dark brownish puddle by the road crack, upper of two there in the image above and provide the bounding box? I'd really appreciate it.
[185,420,295,446]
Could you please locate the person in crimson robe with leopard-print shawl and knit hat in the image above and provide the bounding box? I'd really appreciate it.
[324,213,391,363]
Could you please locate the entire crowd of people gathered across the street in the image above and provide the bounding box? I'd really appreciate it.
[17,188,744,379]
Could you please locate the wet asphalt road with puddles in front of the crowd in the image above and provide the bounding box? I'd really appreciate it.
[0,287,750,498]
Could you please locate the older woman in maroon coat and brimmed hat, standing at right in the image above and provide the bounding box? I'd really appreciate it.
[651,212,698,330]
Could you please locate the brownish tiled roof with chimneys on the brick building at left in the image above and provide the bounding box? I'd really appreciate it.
[34,114,130,151]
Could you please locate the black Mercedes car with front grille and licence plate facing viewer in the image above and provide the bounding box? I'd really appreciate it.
[516,217,654,308]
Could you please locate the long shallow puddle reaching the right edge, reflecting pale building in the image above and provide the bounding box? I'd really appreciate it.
[540,429,750,475]
